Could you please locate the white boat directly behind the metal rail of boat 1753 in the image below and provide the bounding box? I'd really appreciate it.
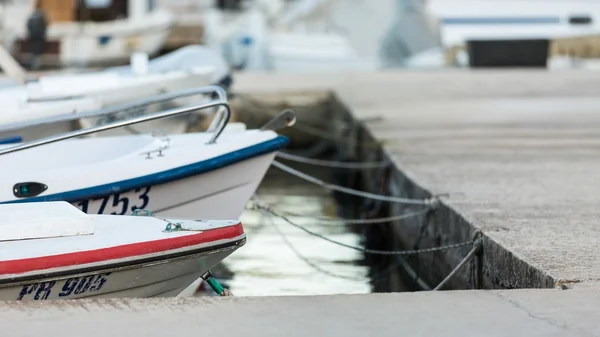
[0,67,213,141]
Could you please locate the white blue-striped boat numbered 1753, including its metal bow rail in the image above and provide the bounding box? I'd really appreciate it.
[0,93,295,297]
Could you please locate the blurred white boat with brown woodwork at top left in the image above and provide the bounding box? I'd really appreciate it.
[3,0,175,67]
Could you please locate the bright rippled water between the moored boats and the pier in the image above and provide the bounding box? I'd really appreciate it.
[225,167,371,296]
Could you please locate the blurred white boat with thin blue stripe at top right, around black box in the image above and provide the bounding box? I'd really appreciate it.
[427,0,600,68]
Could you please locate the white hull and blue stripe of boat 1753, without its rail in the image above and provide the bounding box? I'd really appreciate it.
[0,130,287,219]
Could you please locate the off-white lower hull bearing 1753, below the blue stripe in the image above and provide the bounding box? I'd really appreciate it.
[71,152,275,220]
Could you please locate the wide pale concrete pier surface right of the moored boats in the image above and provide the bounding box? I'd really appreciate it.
[235,70,600,289]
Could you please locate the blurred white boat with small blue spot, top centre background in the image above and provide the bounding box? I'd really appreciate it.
[205,8,374,72]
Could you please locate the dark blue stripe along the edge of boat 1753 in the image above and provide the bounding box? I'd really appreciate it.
[0,136,289,204]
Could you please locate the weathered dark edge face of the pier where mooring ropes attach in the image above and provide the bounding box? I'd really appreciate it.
[331,93,557,290]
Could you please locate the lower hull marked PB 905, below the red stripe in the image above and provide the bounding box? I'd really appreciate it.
[0,236,245,301]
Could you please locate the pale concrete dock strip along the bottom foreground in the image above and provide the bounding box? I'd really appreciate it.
[0,286,600,337]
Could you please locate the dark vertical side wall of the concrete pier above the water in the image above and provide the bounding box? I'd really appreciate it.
[331,95,554,291]
